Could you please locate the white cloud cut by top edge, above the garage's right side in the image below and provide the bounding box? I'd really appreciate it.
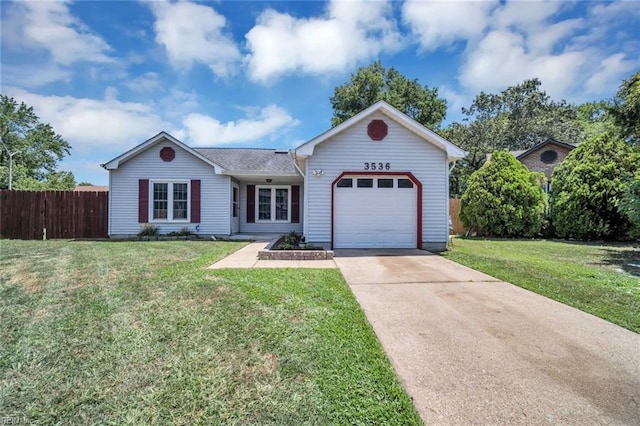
[402,0,498,51]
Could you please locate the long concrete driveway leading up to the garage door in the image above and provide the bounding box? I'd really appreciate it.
[334,250,640,425]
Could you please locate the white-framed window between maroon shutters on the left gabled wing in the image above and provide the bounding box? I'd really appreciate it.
[149,181,191,222]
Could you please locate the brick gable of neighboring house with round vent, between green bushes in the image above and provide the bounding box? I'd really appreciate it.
[511,138,575,192]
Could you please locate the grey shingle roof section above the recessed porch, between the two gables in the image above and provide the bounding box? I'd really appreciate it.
[193,148,298,176]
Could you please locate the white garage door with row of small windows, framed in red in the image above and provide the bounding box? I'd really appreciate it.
[333,176,417,248]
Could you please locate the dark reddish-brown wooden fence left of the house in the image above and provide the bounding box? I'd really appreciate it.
[0,189,109,240]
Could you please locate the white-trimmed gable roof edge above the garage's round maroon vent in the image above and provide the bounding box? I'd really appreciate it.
[295,101,467,161]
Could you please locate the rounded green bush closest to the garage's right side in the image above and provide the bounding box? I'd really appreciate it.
[460,150,547,237]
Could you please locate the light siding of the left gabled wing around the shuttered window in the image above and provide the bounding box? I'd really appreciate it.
[109,141,231,235]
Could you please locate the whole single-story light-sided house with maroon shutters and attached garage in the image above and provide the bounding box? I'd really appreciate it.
[103,101,466,250]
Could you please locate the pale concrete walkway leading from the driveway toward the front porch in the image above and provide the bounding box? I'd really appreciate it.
[209,241,337,269]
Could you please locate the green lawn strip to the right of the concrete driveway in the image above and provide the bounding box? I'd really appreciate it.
[444,238,640,333]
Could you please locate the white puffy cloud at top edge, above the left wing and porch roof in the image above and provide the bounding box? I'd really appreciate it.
[149,1,240,77]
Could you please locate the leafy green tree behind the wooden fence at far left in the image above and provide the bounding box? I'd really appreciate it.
[0,94,73,189]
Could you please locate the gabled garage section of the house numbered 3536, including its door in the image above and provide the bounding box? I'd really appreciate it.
[291,101,466,251]
